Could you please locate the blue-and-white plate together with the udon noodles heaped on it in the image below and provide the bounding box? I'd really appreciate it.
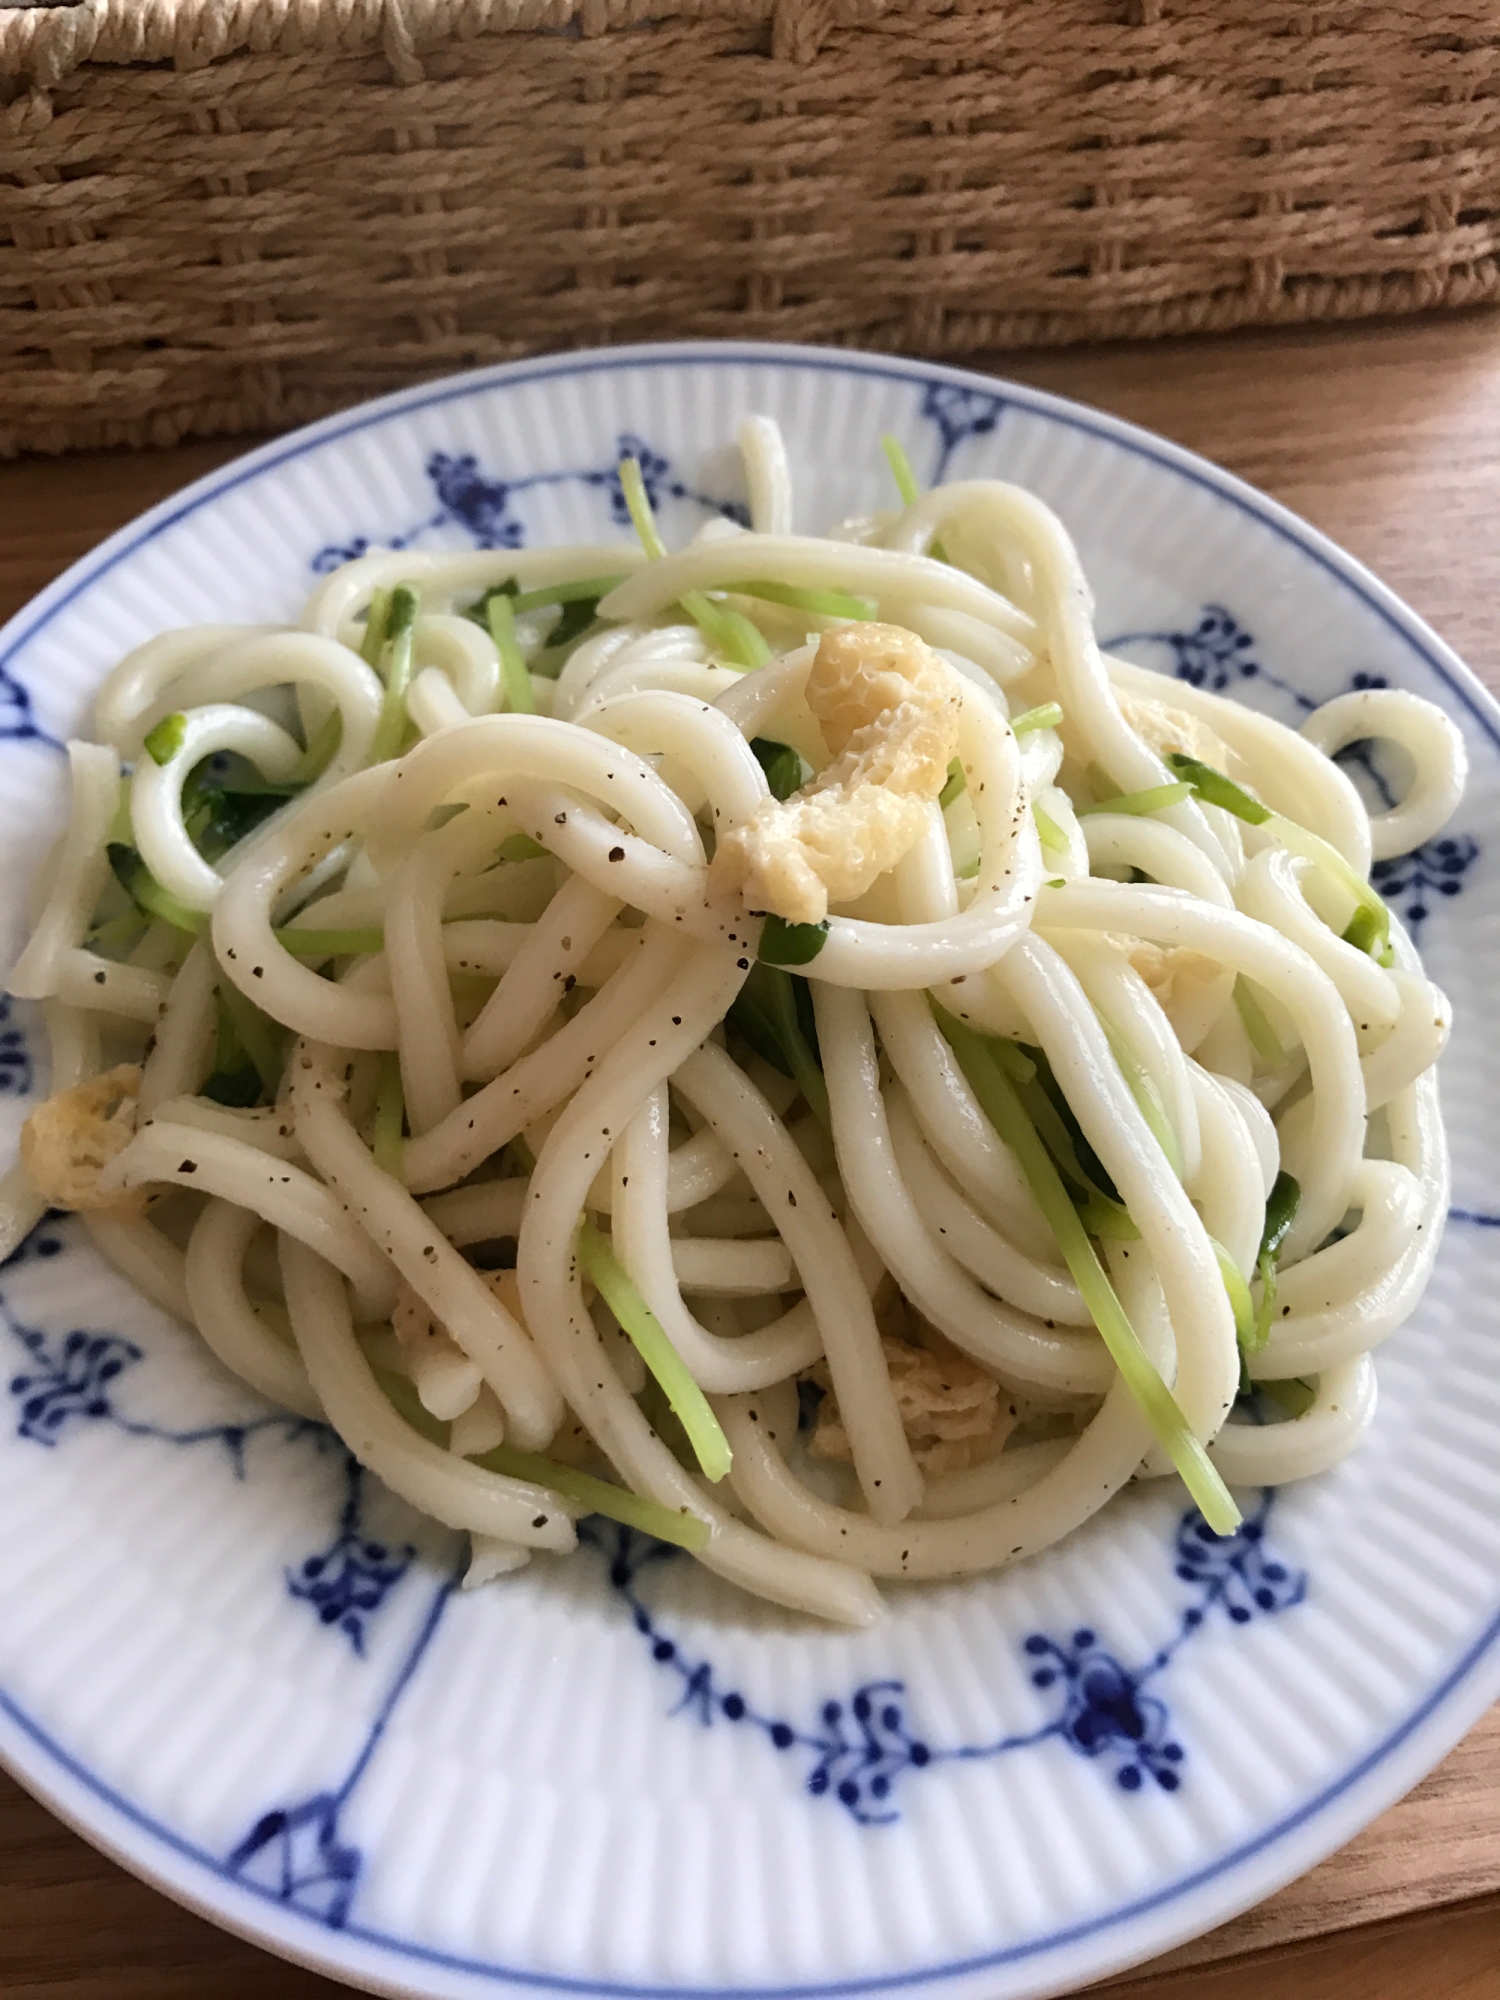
[0,346,1500,2000]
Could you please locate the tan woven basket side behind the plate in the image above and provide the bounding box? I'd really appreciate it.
[0,0,1500,452]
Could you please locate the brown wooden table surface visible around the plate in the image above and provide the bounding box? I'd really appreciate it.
[0,314,1500,2000]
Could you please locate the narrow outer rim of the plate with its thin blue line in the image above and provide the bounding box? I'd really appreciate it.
[0,340,1500,2000]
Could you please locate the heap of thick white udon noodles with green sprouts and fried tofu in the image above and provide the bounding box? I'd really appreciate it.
[0,418,1464,1624]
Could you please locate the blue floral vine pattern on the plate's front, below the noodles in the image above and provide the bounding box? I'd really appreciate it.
[0,1234,1306,1926]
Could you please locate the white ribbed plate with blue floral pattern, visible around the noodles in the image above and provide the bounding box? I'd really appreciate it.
[0,346,1500,2000]
